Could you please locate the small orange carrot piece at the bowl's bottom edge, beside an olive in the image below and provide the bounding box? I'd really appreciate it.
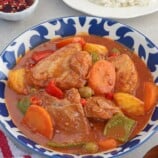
[98,138,117,150]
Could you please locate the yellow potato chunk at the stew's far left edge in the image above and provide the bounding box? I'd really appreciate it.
[8,68,25,94]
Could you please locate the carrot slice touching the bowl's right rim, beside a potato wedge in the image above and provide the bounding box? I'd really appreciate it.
[144,82,158,111]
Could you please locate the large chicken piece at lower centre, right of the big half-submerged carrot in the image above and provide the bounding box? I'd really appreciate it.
[36,88,90,141]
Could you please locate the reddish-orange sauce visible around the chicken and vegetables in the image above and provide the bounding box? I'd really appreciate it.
[5,35,154,154]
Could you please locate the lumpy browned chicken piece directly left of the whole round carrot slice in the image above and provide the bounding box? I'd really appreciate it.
[55,51,92,89]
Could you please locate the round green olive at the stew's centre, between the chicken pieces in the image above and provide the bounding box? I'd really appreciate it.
[79,86,94,98]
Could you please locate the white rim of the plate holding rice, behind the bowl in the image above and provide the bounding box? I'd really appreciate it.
[63,0,158,19]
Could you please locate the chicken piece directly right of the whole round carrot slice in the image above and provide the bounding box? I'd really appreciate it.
[109,54,138,94]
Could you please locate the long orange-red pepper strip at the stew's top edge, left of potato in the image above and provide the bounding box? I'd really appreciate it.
[56,37,86,49]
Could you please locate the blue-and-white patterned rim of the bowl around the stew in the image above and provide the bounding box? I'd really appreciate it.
[0,16,158,158]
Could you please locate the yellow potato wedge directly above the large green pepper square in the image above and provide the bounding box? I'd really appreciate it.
[114,92,144,116]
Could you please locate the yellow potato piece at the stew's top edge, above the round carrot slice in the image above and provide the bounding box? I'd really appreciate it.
[83,43,108,56]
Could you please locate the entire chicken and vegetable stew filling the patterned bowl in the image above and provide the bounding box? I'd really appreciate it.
[5,35,157,154]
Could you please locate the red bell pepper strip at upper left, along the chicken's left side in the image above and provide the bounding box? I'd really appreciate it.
[32,50,53,62]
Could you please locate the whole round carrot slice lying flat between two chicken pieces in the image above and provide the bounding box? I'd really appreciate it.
[88,60,116,94]
